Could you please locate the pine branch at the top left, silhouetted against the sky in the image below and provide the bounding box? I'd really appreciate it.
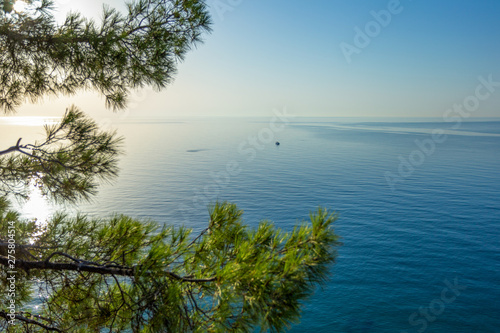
[0,0,210,111]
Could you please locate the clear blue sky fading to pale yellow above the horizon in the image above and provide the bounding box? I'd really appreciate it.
[13,0,500,118]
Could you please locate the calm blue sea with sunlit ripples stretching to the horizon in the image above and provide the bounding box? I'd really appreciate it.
[0,115,500,333]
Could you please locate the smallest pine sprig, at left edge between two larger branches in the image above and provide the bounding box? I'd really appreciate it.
[0,106,122,202]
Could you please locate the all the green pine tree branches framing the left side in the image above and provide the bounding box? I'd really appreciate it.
[0,0,340,332]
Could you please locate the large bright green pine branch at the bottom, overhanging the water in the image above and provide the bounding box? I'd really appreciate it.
[0,198,340,332]
